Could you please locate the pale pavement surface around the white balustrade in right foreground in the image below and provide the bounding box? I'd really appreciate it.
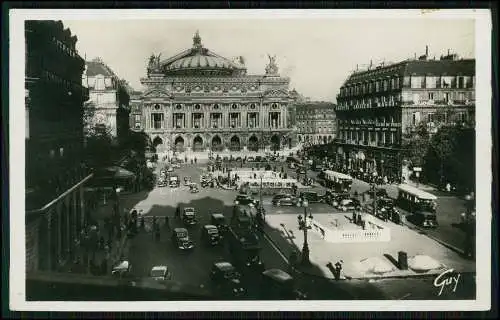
[264,214,475,279]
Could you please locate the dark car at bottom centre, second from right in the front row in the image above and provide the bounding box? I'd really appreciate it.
[210,262,246,298]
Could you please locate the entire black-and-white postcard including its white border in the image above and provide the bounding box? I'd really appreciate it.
[10,10,491,310]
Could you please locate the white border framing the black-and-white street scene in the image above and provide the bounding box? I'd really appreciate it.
[9,9,492,311]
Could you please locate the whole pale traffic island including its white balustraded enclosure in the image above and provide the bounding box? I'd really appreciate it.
[264,213,475,279]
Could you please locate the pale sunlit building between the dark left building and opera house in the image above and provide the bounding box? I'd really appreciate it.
[82,58,130,140]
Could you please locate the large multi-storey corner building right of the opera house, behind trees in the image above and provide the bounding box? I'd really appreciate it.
[335,52,475,178]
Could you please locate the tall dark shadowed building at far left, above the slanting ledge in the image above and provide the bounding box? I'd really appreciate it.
[25,21,88,190]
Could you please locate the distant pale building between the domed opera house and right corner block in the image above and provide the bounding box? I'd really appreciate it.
[295,102,337,144]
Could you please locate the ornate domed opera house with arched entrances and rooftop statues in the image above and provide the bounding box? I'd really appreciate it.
[133,33,295,152]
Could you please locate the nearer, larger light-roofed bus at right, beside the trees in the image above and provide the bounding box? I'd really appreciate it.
[396,184,438,228]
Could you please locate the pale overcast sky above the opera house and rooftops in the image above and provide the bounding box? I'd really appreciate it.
[63,16,475,101]
